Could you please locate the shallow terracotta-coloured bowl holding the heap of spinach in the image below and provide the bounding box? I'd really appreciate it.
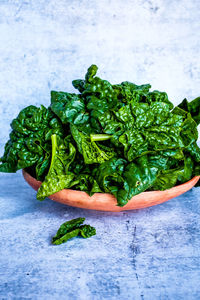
[22,170,200,212]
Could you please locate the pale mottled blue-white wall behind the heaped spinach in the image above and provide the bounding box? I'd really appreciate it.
[0,0,200,151]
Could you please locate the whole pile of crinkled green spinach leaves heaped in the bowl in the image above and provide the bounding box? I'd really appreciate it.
[0,65,200,206]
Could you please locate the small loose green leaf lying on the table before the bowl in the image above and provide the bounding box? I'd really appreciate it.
[52,218,96,245]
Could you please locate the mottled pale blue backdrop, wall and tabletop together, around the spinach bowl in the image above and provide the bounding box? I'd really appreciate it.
[0,0,200,300]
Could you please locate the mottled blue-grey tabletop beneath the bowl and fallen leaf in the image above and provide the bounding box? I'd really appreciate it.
[0,172,200,300]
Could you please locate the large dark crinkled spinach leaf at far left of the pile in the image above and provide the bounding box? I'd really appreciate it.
[0,105,63,179]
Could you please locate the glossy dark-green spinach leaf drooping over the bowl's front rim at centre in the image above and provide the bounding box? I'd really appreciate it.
[95,156,159,206]
